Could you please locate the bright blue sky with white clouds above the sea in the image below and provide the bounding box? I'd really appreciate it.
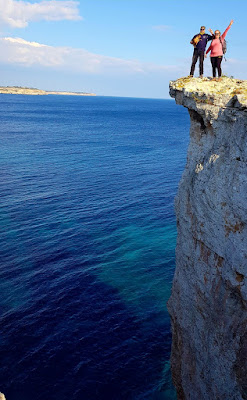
[0,0,247,99]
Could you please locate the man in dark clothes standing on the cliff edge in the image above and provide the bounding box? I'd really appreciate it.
[190,26,213,78]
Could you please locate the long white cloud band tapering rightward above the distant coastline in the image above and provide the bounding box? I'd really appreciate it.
[0,37,179,75]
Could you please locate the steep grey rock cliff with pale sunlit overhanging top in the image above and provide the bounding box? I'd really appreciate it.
[168,78,247,400]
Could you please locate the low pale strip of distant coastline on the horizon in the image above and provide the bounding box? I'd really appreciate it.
[0,86,96,96]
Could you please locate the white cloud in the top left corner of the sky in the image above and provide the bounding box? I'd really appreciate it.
[0,0,82,28]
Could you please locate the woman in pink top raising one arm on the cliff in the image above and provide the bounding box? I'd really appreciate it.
[205,20,233,80]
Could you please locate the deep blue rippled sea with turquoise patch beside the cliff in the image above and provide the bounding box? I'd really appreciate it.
[0,95,189,400]
